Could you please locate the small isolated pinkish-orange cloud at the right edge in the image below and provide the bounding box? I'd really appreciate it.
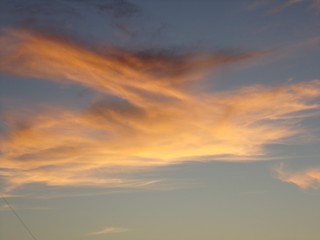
[275,165,320,190]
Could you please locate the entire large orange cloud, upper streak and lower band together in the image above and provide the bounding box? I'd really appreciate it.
[0,28,320,192]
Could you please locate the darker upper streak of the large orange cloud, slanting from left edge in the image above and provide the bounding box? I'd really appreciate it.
[0,30,266,105]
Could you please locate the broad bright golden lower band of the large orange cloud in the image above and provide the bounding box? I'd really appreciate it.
[1,81,320,193]
